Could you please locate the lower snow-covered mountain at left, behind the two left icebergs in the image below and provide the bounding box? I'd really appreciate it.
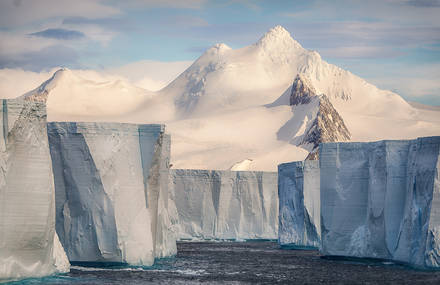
[24,68,155,121]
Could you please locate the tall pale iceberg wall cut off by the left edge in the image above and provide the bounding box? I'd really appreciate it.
[0,99,70,283]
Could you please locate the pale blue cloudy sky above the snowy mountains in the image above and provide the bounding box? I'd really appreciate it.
[0,0,440,105]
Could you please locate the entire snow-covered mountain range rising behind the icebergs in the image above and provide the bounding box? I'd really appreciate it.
[17,26,440,170]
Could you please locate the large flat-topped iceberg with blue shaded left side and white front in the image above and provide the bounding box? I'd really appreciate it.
[47,122,176,265]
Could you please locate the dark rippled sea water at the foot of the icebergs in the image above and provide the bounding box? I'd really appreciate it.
[10,241,440,285]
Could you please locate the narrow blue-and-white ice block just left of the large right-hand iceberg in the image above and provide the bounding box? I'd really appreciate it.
[278,160,321,247]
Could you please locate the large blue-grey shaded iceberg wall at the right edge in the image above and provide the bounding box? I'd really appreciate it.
[320,137,440,268]
